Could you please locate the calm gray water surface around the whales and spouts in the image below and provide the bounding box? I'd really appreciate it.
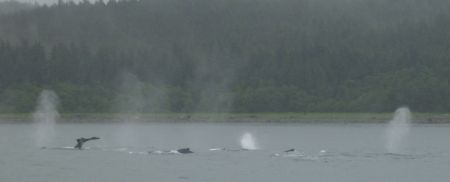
[0,123,450,182]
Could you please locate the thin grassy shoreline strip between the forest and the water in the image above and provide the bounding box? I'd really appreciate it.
[0,113,450,124]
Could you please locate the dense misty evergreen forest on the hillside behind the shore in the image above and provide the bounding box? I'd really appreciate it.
[0,0,450,112]
